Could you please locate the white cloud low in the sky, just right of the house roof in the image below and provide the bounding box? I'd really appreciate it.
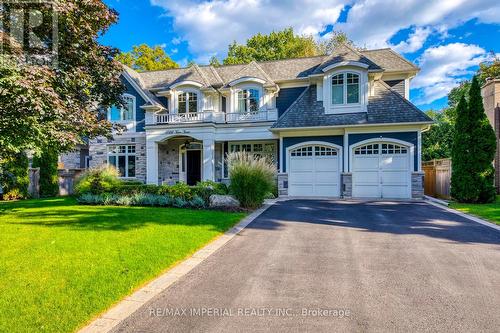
[411,43,489,104]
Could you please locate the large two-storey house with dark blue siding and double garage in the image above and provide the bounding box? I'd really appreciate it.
[89,45,432,198]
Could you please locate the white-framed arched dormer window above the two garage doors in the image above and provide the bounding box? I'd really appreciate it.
[331,72,360,105]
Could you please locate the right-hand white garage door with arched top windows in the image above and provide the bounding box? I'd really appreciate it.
[352,143,411,198]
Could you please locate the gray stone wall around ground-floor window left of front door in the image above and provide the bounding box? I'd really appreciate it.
[89,133,146,182]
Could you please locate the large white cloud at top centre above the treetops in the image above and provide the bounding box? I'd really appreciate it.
[151,0,350,58]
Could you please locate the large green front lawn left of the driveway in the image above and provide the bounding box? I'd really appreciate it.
[0,198,245,332]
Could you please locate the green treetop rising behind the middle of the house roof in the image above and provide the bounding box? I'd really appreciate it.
[223,28,318,65]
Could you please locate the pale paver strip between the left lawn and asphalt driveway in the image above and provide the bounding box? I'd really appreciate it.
[78,199,280,333]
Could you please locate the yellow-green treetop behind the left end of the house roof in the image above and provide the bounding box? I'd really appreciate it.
[116,44,179,72]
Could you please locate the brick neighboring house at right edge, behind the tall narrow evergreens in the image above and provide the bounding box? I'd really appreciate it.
[481,79,500,193]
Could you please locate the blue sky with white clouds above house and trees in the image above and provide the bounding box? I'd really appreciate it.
[101,0,500,110]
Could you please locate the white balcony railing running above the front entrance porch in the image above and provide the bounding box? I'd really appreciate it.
[150,109,278,125]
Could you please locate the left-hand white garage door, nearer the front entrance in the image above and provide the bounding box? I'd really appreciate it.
[288,145,340,197]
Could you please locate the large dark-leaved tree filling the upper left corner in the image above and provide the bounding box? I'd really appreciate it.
[0,0,124,160]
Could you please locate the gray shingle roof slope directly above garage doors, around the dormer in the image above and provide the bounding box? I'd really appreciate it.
[272,81,432,129]
